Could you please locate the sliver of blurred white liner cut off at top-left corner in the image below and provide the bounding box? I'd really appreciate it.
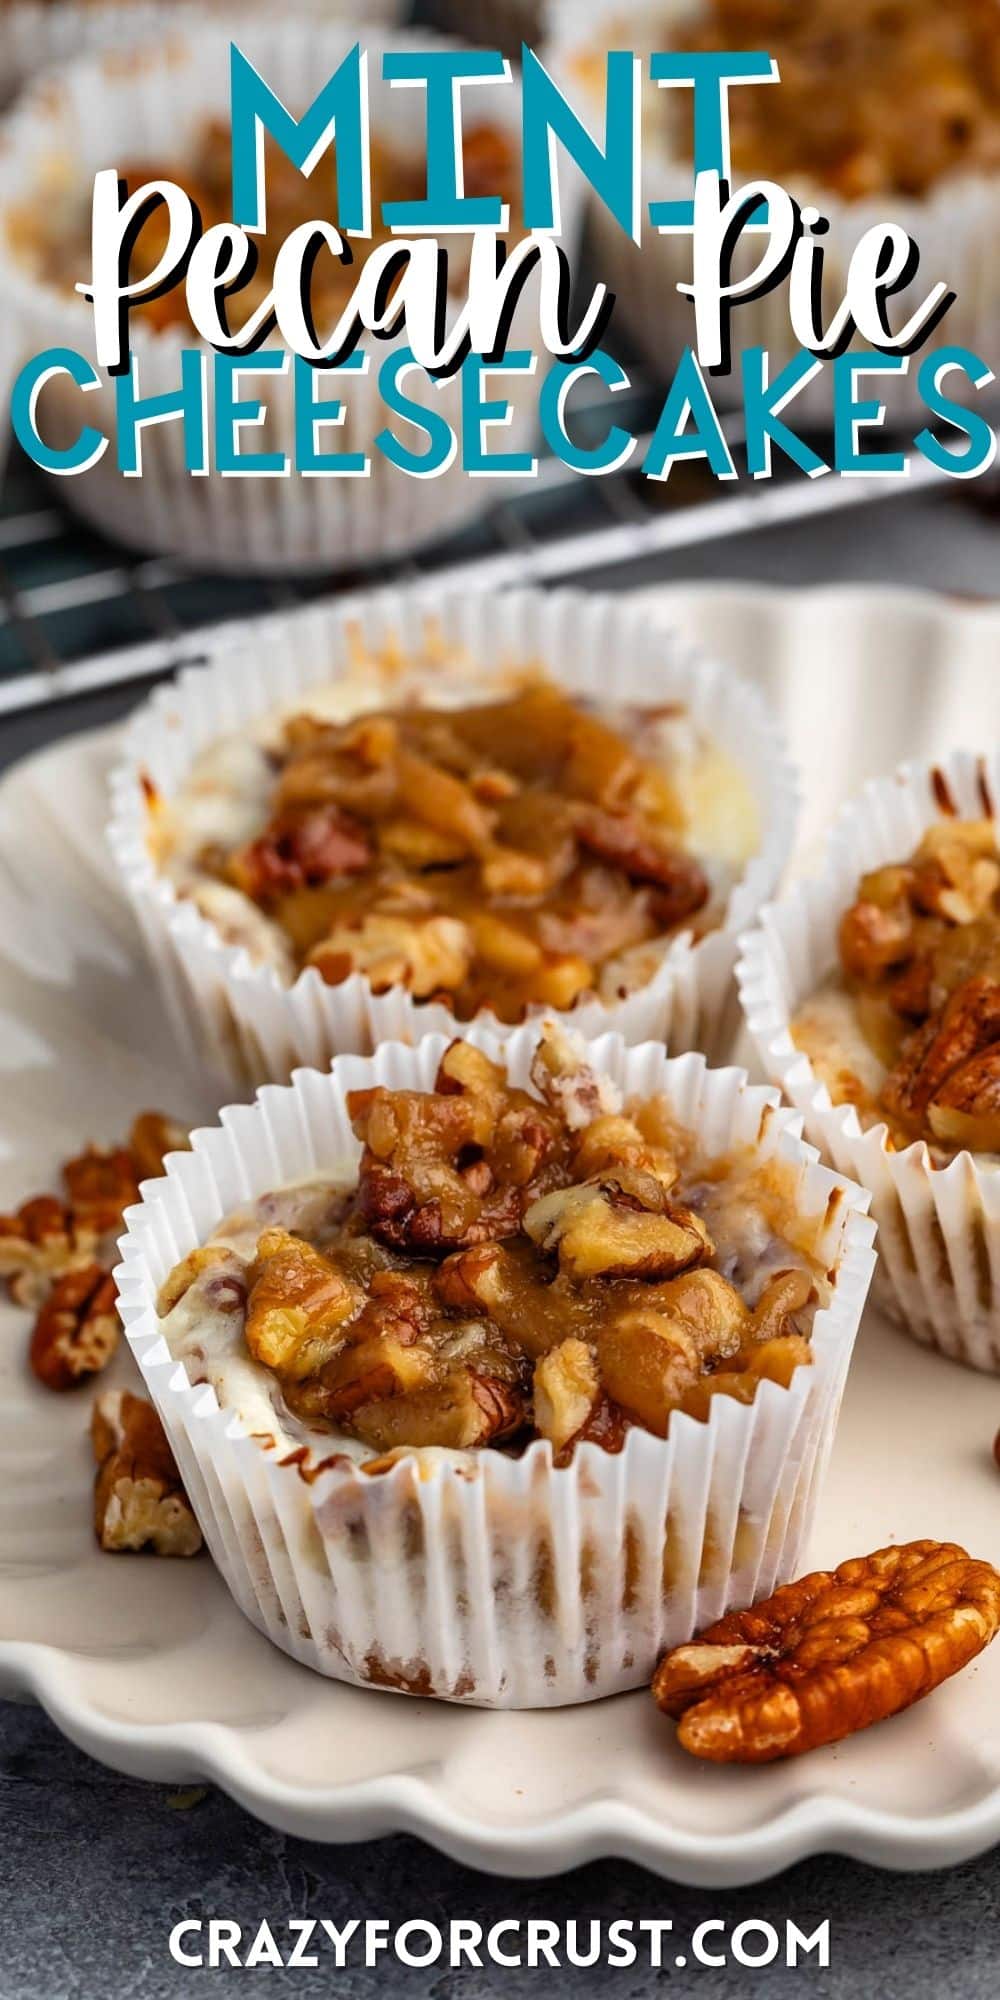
[0,0,406,104]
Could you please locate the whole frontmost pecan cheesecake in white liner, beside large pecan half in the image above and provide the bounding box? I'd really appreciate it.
[118,1026,872,1706]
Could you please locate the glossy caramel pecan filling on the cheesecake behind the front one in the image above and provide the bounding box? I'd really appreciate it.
[154,678,746,1022]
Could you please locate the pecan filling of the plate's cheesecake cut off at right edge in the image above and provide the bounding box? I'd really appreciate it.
[792,818,1000,1152]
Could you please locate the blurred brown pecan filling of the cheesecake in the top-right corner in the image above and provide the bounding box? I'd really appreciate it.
[660,0,1000,202]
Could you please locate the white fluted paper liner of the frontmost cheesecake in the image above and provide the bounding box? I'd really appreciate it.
[116,1028,874,1708]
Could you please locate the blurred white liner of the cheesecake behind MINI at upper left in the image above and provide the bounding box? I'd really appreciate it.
[0,14,582,574]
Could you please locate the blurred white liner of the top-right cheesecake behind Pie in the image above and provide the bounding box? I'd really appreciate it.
[546,0,1000,428]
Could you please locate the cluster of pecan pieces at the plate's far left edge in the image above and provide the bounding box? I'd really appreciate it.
[0,1112,188,1390]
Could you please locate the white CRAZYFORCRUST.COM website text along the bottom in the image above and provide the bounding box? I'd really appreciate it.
[170,1916,830,1970]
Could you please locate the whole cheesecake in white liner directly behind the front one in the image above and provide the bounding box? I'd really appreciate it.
[110,592,794,1088]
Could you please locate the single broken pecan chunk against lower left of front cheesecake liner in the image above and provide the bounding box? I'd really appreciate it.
[90,1390,202,1556]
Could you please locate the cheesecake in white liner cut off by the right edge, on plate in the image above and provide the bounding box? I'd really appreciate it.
[738,752,1000,1370]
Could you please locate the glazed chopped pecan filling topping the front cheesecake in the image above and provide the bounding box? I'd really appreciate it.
[160,1036,824,1460]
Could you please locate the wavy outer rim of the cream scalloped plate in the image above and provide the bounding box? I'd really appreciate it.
[0,578,1000,1888]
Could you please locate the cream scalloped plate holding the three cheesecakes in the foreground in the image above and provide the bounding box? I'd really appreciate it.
[0,586,1000,1884]
